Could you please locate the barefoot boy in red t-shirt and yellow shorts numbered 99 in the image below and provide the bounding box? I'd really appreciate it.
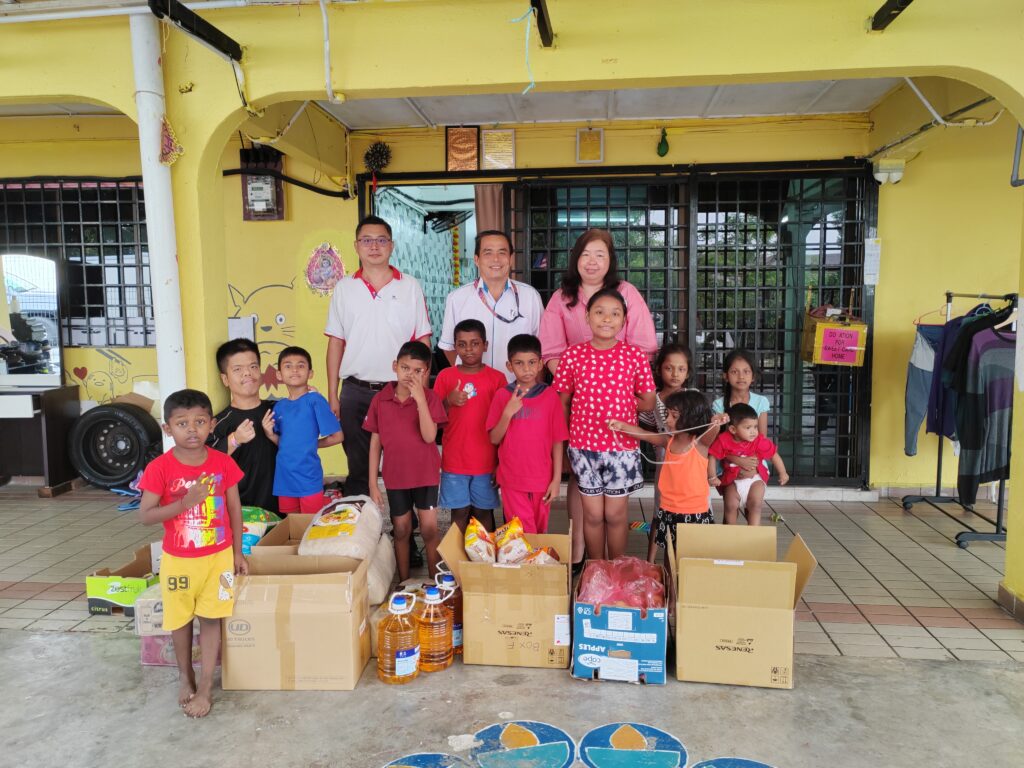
[138,389,249,718]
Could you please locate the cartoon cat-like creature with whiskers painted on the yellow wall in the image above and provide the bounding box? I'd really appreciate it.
[227,278,299,396]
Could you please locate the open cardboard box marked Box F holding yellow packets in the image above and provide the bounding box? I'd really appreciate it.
[438,526,572,670]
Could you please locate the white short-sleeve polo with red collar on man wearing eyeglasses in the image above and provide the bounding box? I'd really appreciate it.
[324,266,430,381]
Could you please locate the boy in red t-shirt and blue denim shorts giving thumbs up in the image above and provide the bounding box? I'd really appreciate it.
[434,319,506,532]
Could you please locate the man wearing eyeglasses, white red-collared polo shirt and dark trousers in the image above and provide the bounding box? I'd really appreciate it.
[324,216,431,496]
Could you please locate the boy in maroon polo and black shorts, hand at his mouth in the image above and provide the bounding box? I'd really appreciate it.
[362,341,447,582]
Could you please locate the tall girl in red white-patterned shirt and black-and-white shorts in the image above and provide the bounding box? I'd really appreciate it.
[554,289,654,559]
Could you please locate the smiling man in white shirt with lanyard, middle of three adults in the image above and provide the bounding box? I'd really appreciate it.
[437,229,544,383]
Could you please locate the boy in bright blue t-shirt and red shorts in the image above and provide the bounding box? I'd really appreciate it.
[273,347,342,514]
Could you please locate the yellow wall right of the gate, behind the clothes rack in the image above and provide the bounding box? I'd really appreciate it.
[870,81,1024,486]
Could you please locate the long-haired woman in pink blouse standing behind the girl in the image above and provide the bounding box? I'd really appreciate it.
[540,229,657,566]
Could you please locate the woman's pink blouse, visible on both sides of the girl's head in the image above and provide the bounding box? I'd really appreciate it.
[540,281,657,362]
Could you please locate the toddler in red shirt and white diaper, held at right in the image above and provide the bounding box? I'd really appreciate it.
[708,402,790,525]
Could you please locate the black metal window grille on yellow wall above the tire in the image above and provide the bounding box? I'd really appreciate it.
[0,179,156,347]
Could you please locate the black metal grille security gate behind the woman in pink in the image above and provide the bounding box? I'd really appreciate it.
[506,167,872,485]
